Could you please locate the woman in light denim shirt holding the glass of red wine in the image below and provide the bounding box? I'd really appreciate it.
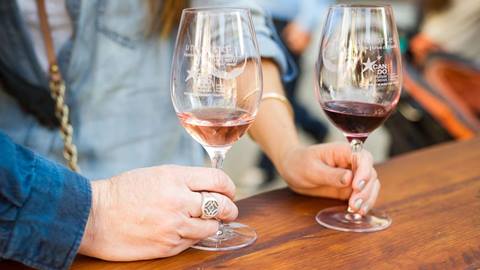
[0,0,380,266]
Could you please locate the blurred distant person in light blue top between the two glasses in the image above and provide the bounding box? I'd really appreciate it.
[258,0,331,183]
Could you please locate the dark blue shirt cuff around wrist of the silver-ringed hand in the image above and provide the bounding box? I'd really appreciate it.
[2,153,92,270]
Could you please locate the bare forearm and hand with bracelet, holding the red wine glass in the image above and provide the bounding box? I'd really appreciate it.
[249,59,380,214]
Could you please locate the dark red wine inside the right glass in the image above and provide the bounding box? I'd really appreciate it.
[323,101,390,141]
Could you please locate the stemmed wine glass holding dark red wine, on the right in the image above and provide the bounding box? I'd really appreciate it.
[315,5,402,232]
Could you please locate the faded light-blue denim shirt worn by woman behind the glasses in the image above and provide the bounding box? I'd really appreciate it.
[0,0,291,179]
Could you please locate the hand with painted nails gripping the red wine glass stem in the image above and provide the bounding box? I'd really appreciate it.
[277,143,380,215]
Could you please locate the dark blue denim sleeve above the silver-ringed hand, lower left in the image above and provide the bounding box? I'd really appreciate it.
[0,132,92,269]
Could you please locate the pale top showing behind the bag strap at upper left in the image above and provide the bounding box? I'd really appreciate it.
[17,0,72,71]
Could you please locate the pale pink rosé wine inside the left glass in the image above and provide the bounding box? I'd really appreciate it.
[177,108,253,146]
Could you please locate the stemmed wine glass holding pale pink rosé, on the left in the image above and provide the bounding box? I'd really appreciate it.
[171,8,262,251]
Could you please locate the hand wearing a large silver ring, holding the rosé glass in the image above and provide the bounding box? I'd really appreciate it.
[79,166,238,261]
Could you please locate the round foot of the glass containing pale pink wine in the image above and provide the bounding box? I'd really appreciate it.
[193,222,257,251]
